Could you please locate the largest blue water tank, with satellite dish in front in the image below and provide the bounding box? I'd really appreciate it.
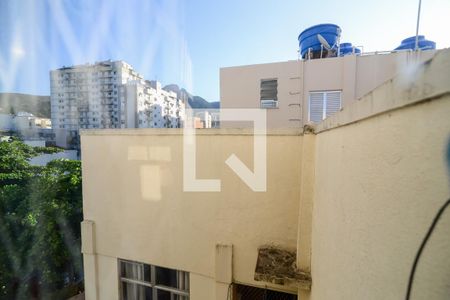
[298,24,341,58]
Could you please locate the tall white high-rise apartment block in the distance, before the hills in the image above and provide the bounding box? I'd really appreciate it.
[50,61,184,148]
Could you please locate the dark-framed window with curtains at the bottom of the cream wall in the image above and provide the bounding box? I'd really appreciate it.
[119,260,189,300]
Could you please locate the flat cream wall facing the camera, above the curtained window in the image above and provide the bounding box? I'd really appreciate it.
[81,129,302,300]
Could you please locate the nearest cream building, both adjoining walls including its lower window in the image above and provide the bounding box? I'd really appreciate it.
[81,50,450,300]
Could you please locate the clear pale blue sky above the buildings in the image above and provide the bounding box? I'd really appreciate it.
[0,0,450,101]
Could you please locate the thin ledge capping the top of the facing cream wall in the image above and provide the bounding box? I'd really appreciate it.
[80,128,303,136]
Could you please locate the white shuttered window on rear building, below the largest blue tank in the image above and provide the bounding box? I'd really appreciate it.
[309,91,342,123]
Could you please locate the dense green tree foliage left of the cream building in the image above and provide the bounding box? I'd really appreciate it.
[0,139,82,299]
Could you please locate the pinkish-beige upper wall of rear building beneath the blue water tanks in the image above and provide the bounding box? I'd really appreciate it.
[220,51,436,128]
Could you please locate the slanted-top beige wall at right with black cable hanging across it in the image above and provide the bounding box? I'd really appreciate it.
[311,51,450,299]
